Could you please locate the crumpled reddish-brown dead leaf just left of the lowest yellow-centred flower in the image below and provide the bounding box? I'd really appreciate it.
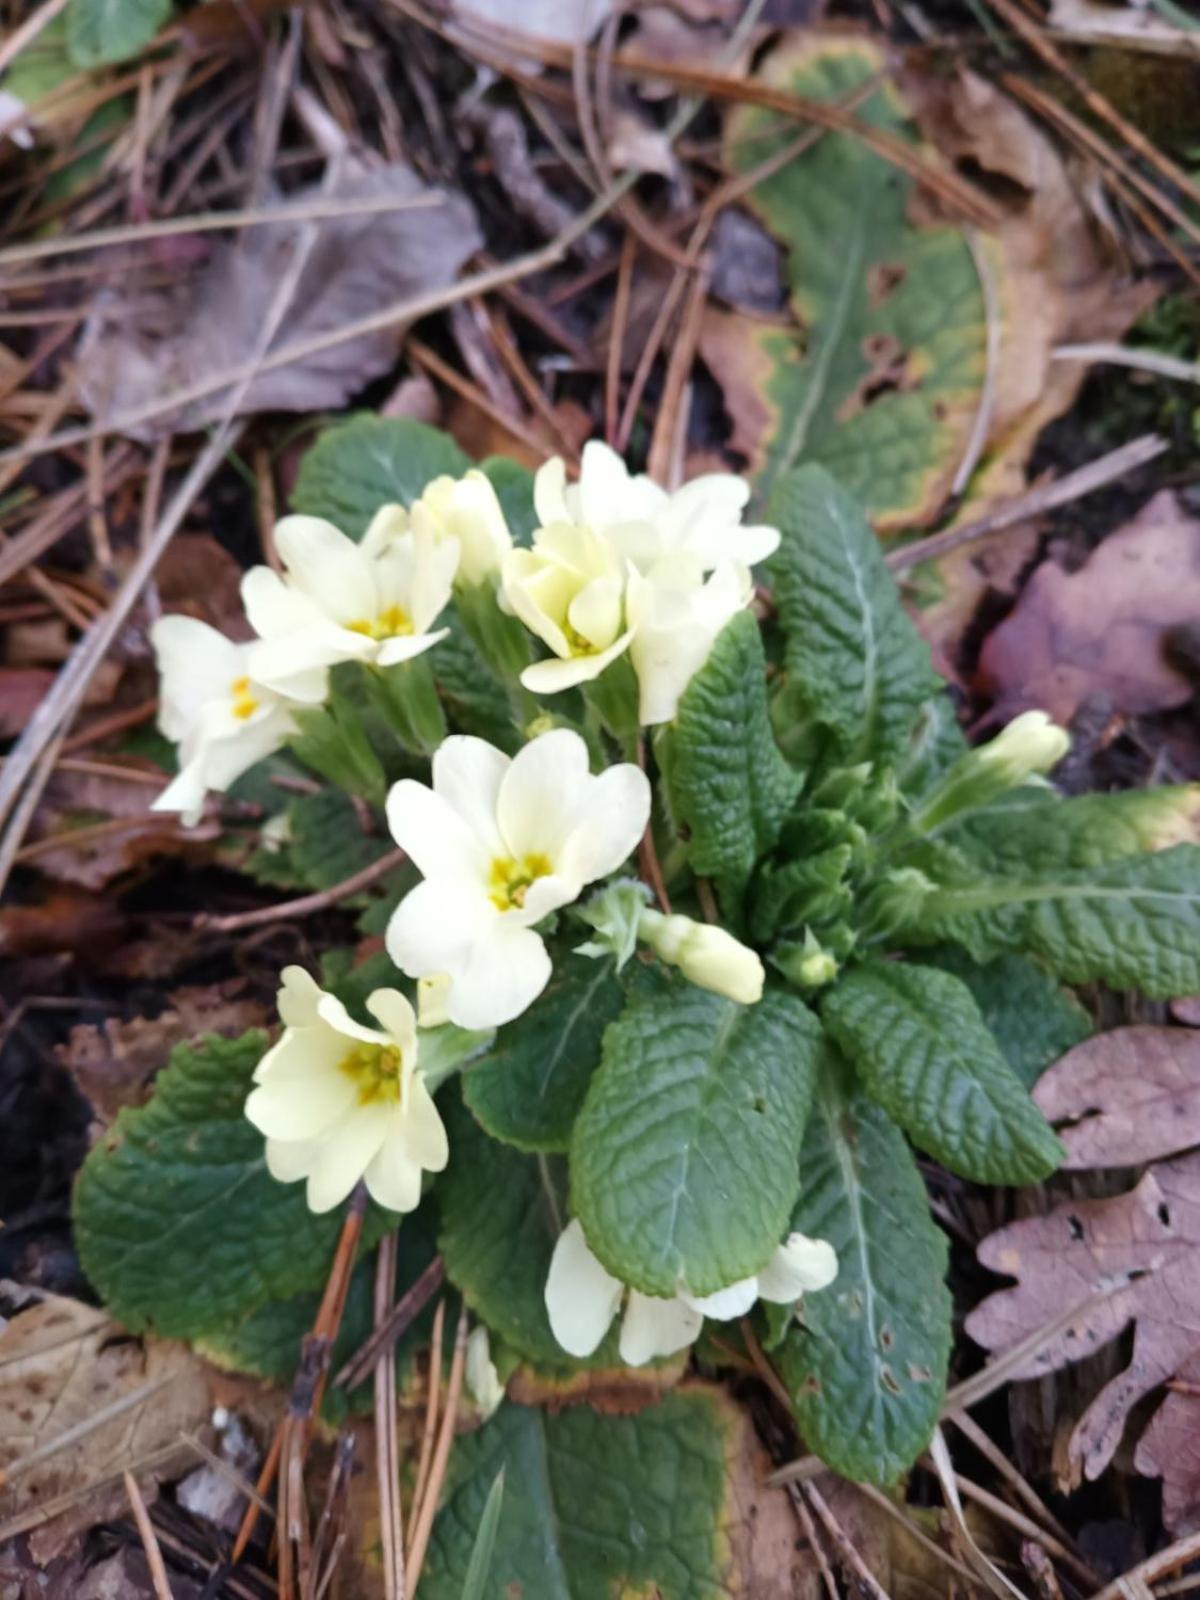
[58,978,267,1134]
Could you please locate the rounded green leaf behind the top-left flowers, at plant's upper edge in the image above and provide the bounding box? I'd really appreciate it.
[291,414,470,539]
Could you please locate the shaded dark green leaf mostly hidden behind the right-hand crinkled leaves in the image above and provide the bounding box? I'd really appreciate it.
[922,944,1093,1090]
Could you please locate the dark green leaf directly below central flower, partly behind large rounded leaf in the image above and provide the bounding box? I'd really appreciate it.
[462,957,624,1150]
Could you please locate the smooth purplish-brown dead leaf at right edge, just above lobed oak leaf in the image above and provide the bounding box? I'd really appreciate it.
[1034,1026,1200,1168]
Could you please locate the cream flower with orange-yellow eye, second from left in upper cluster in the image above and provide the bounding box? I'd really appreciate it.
[242,506,459,698]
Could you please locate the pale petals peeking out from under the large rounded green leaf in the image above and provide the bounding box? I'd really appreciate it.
[546,1221,837,1366]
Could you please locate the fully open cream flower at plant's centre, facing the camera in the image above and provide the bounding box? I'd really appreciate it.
[387,728,650,1029]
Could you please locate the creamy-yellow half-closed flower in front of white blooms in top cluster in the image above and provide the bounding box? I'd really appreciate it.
[501,523,634,694]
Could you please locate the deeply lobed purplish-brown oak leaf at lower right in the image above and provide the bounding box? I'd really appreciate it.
[965,1155,1200,1480]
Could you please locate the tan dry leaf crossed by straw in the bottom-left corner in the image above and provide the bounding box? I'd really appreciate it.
[0,1296,213,1562]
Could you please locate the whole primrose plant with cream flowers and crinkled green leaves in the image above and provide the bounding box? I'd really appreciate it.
[77,418,1200,1482]
